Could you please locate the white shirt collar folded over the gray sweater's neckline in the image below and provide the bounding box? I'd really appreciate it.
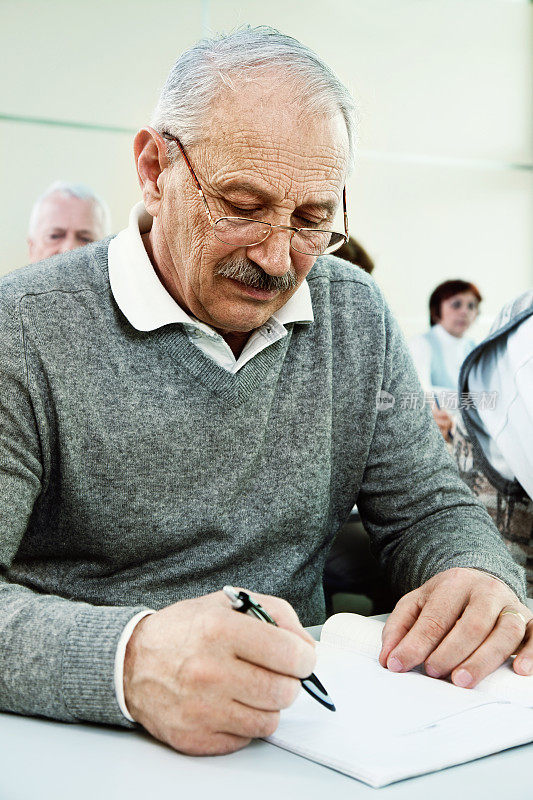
[109,202,314,333]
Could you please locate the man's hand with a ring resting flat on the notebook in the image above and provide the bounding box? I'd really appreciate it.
[379,567,533,688]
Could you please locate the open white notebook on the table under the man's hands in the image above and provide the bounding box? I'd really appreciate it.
[267,614,533,787]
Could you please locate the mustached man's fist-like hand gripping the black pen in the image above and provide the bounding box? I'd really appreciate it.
[124,592,316,755]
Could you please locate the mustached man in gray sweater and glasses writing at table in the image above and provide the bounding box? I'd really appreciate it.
[0,28,532,754]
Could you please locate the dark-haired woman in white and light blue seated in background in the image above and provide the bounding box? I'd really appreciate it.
[409,279,482,440]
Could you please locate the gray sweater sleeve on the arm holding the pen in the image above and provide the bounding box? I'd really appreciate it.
[0,292,148,726]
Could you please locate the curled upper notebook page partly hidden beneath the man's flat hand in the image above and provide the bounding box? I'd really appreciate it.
[320,613,533,708]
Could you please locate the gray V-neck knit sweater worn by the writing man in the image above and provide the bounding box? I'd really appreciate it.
[0,241,524,725]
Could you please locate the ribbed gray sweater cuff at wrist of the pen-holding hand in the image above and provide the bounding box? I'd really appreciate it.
[61,606,151,728]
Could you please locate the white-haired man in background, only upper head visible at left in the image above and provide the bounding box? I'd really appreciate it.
[28,181,110,264]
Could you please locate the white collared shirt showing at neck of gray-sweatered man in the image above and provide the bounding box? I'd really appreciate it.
[109,203,314,373]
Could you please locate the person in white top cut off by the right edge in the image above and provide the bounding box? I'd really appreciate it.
[454,289,533,597]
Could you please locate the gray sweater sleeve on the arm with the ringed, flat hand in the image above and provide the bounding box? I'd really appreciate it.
[357,308,525,599]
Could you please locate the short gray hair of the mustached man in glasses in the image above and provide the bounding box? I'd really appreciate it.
[151,26,355,172]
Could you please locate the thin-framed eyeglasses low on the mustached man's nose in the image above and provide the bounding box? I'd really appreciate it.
[161,133,348,256]
